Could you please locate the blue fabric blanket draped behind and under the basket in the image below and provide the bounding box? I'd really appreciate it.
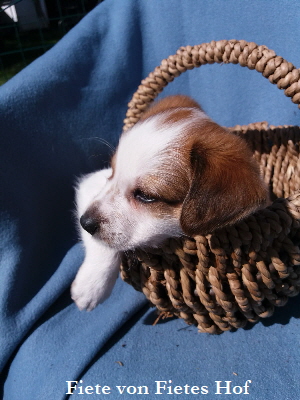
[0,0,300,400]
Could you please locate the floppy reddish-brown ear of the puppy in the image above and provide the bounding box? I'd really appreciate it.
[180,122,268,236]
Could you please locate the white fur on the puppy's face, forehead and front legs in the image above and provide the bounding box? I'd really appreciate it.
[71,109,208,310]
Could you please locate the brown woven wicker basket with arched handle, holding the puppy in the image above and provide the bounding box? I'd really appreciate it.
[121,40,300,333]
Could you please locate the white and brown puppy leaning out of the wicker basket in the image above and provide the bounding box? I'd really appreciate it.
[71,96,268,310]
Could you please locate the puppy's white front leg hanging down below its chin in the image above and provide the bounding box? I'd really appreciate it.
[71,237,120,311]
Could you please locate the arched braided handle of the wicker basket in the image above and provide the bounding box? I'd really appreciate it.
[123,40,300,131]
